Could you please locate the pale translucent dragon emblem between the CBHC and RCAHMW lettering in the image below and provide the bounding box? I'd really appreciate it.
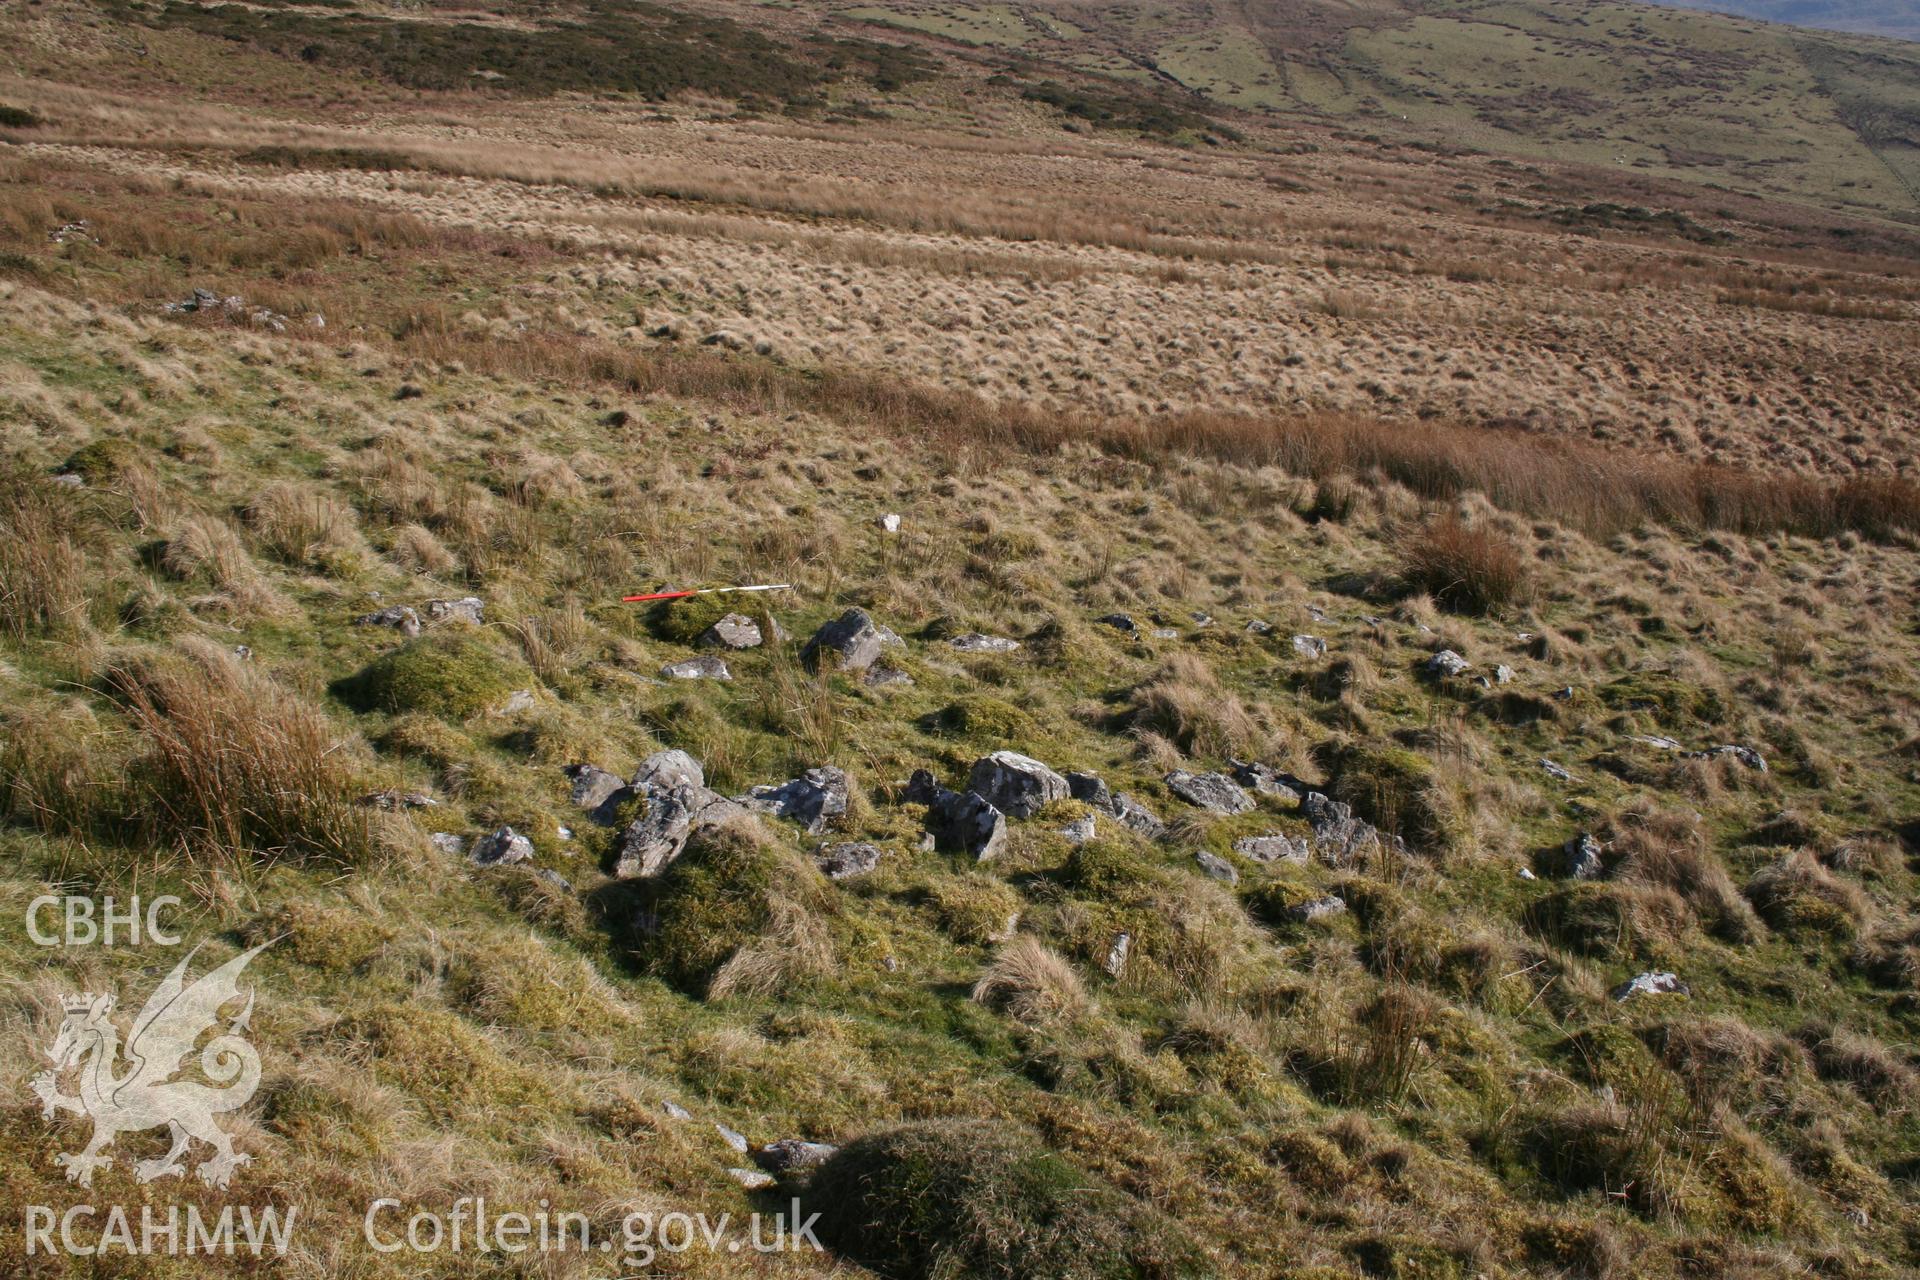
[33,942,271,1188]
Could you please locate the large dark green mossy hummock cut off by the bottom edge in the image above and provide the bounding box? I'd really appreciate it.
[806,1121,1213,1280]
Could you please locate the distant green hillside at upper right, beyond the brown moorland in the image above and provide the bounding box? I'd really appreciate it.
[829,0,1920,221]
